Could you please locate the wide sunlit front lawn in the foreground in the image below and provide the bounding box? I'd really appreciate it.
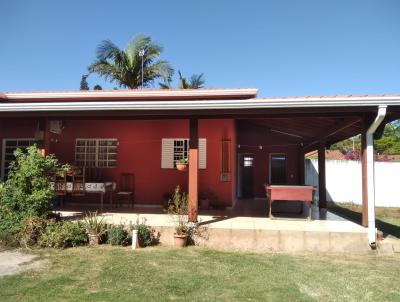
[0,246,400,302]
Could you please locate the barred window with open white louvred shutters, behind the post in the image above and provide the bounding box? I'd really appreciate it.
[161,138,207,169]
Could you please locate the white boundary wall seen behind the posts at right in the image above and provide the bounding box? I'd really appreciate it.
[305,159,400,207]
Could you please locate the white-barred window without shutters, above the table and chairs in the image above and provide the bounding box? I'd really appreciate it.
[75,138,118,168]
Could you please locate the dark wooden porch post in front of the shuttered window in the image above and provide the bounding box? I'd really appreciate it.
[189,118,199,222]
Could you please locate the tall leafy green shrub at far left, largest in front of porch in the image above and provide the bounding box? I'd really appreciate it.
[0,146,69,244]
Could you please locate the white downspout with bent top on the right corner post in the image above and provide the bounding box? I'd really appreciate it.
[366,105,387,249]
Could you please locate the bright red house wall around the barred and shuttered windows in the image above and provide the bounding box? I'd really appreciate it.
[0,119,235,206]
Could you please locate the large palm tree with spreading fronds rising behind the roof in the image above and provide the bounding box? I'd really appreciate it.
[88,35,173,89]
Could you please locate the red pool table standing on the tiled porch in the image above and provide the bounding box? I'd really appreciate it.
[264,185,315,220]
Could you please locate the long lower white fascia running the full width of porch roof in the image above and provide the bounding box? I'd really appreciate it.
[0,96,400,112]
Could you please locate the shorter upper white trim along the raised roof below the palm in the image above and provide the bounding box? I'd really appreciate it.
[3,88,258,100]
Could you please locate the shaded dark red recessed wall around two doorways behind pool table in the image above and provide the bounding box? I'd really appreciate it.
[236,123,300,198]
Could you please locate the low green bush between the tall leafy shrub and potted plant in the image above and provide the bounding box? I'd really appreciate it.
[38,221,88,248]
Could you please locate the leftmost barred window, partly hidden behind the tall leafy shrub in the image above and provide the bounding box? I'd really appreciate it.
[1,138,35,179]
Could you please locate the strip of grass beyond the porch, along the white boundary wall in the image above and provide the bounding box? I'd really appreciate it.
[328,202,400,238]
